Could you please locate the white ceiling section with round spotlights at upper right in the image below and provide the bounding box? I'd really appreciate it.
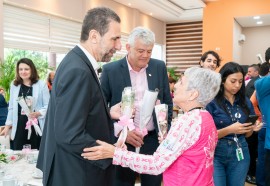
[235,14,270,27]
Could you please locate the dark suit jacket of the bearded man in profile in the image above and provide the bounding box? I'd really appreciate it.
[37,46,113,186]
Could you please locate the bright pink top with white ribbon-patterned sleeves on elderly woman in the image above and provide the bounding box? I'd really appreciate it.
[113,109,217,186]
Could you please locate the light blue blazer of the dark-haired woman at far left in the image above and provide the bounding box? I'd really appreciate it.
[6,80,50,140]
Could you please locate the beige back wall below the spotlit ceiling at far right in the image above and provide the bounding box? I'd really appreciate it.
[242,26,270,65]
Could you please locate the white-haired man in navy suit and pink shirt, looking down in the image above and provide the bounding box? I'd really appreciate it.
[101,27,172,186]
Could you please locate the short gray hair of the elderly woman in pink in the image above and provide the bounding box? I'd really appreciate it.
[184,67,221,107]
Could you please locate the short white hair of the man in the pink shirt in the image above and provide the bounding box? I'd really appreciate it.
[128,27,155,46]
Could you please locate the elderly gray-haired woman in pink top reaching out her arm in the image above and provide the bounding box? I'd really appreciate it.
[82,67,221,186]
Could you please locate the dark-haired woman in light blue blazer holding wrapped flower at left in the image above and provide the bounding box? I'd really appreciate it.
[1,58,50,150]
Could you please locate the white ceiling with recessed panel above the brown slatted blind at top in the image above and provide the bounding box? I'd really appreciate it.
[114,0,206,23]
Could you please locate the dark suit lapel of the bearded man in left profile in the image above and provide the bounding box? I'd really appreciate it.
[73,46,111,117]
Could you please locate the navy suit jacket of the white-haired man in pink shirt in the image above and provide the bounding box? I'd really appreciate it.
[101,57,173,135]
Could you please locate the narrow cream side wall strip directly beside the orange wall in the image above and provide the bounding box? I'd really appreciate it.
[233,20,244,64]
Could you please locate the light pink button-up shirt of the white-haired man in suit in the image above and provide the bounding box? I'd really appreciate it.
[126,58,155,131]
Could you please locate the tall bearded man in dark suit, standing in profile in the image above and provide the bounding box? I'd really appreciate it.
[37,8,121,186]
